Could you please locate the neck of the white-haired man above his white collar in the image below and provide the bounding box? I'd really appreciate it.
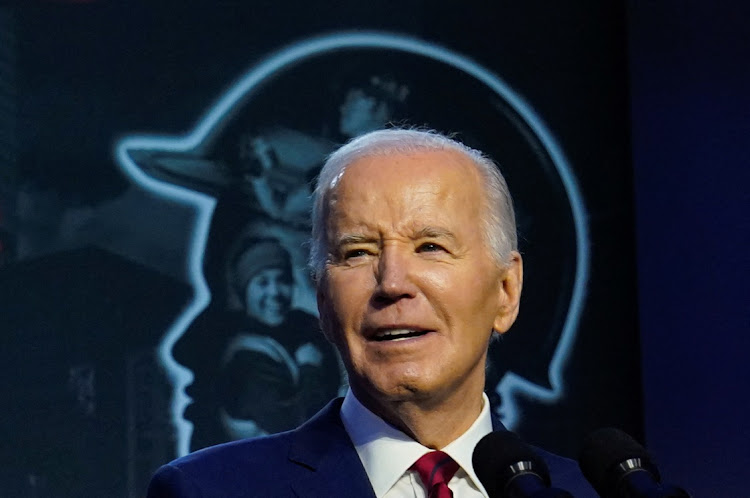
[354,385,484,450]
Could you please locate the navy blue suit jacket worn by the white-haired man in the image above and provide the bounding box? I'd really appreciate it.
[148,398,597,498]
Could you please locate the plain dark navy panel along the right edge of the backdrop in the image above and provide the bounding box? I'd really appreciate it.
[629,1,750,497]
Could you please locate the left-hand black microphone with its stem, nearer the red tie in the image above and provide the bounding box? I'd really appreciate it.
[471,431,573,498]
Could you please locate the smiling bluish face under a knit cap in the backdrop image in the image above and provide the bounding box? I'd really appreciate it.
[245,268,292,326]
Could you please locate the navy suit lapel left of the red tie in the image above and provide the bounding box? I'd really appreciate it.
[289,398,375,498]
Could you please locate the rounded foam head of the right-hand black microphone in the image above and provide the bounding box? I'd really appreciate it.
[578,427,661,497]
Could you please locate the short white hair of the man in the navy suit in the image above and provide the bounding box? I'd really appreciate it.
[310,128,518,281]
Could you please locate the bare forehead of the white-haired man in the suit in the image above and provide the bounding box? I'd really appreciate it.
[328,150,484,230]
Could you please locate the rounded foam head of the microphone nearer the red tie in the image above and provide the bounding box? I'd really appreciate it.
[471,431,550,497]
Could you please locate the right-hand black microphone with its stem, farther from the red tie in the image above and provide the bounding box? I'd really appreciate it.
[578,428,690,498]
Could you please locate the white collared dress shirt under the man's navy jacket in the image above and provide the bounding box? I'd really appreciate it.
[341,390,492,498]
